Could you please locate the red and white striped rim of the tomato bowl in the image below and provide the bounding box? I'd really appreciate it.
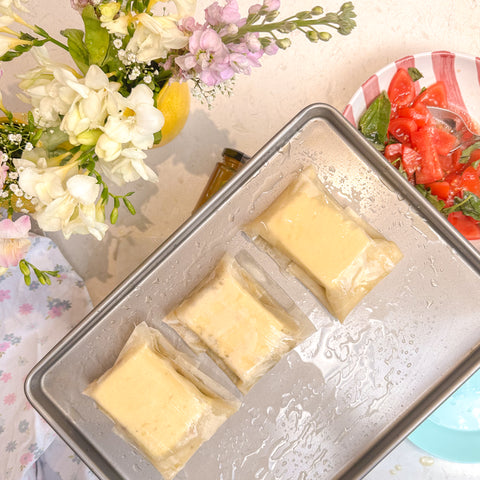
[343,51,480,126]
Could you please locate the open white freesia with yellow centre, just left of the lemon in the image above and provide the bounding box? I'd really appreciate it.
[102,84,165,150]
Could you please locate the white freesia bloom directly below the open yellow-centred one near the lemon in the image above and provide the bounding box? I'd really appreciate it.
[98,147,158,185]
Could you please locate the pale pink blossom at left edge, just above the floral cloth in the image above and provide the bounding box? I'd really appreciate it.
[0,215,31,268]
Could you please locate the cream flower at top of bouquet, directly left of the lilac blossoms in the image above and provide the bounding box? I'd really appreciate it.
[126,13,188,63]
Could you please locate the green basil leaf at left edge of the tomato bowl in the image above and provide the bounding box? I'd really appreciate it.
[359,92,392,151]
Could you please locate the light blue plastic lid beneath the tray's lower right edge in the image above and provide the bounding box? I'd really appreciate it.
[408,370,480,463]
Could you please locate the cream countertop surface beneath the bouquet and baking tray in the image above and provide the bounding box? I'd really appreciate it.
[0,0,480,480]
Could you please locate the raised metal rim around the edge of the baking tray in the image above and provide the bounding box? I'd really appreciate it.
[24,103,480,480]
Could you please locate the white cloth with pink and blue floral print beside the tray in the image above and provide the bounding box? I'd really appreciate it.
[0,237,96,480]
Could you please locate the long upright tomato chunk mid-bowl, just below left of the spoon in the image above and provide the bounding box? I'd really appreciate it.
[411,127,443,184]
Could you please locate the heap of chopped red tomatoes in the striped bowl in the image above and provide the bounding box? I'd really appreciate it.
[360,69,480,240]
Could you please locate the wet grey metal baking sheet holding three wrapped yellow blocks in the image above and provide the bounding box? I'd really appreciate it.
[26,104,480,480]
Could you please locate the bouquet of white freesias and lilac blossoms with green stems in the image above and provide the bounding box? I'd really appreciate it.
[0,0,355,284]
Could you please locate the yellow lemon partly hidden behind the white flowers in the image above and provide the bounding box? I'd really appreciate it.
[156,82,190,147]
